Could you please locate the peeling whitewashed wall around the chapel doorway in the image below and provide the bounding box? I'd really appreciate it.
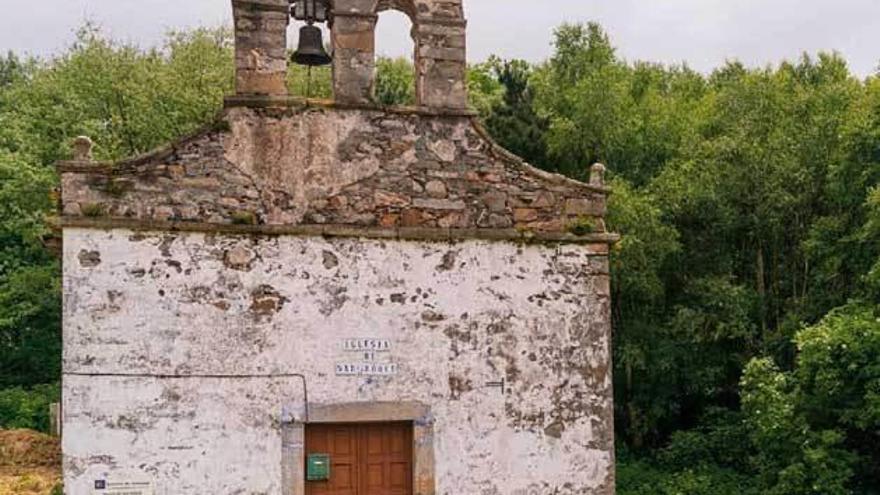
[64,228,613,495]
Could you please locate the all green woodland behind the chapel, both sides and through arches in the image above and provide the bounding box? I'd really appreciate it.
[0,21,880,495]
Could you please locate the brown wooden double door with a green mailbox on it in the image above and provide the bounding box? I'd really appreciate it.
[305,423,413,495]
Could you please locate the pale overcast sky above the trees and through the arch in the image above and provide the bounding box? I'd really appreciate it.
[0,0,880,76]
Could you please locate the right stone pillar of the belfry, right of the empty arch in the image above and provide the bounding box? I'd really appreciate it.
[415,17,467,109]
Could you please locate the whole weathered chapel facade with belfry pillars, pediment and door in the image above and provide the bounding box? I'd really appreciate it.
[58,0,616,495]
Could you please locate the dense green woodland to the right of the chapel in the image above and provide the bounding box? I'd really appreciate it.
[520,25,880,494]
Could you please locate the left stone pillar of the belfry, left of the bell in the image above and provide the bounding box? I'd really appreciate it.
[232,0,290,96]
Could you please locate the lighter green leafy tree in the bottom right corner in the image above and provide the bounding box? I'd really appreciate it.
[743,302,880,495]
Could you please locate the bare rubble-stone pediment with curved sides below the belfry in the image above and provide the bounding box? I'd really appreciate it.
[59,98,614,242]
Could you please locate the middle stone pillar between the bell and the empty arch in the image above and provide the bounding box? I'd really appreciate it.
[332,11,377,104]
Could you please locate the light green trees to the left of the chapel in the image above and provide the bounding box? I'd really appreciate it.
[0,26,233,394]
